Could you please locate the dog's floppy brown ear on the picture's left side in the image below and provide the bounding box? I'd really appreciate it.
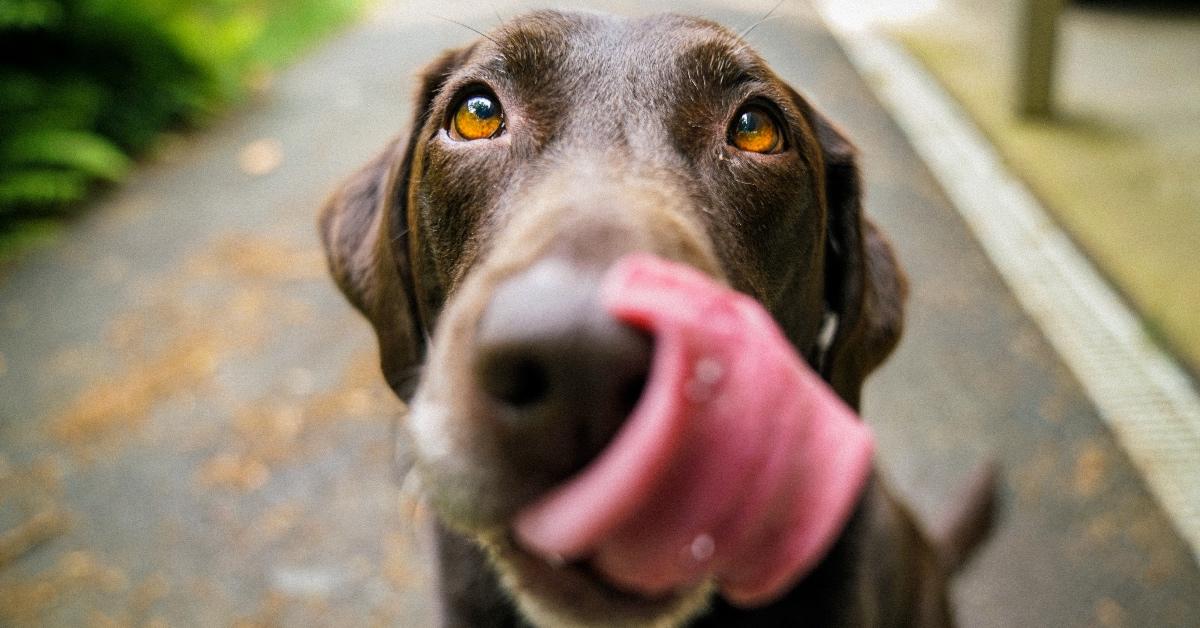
[318,49,469,401]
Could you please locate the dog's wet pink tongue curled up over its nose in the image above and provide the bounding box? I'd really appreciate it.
[515,255,872,605]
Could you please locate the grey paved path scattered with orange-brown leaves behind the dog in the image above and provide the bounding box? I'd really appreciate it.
[0,2,1200,627]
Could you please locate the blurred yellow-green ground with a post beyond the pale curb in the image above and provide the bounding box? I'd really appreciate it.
[868,0,1200,381]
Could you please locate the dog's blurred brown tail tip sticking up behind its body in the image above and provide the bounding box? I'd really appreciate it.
[929,460,1000,573]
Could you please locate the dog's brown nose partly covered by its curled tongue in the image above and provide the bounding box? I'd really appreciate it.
[475,259,652,482]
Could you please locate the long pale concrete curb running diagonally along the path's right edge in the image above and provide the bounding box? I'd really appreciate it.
[817,0,1200,563]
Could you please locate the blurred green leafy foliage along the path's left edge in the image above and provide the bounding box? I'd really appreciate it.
[0,0,364,257]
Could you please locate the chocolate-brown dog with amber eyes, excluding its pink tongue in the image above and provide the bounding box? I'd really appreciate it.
[319,11,994,627]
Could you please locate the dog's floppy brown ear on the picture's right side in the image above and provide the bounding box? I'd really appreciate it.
[809,109,908,408]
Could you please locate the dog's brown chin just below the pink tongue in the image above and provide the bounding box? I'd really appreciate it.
[478,533,713,628]
